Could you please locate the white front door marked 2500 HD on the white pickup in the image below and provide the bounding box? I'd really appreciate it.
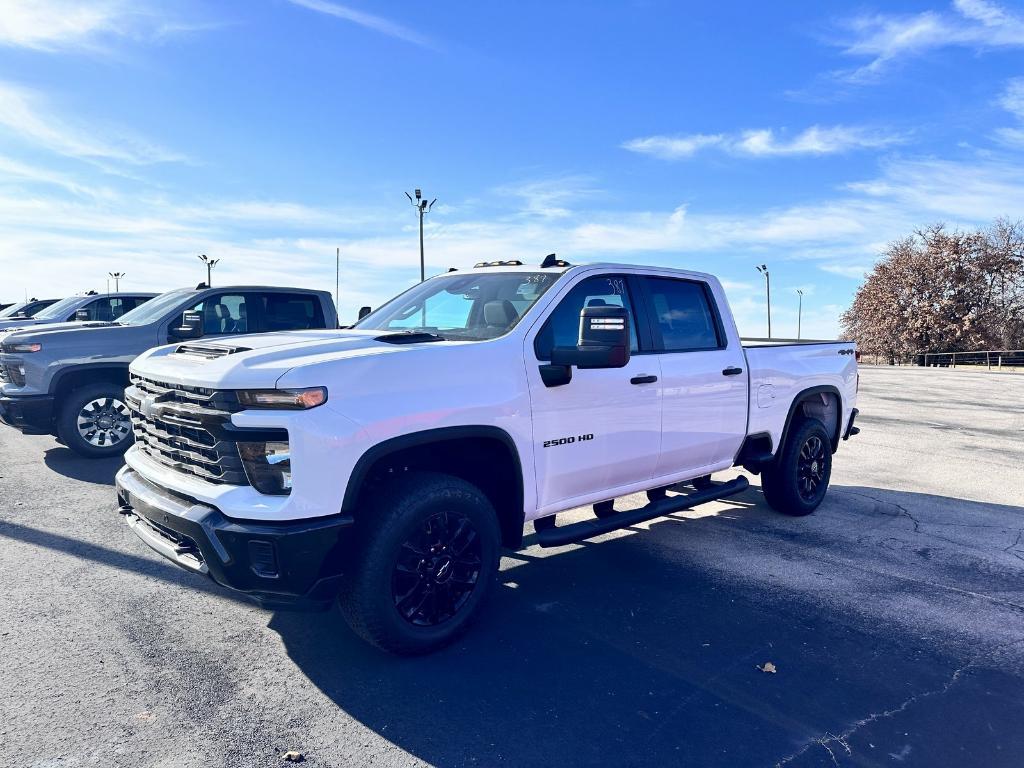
[525,274,662,511]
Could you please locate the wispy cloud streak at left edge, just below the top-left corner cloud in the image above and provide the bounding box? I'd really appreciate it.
[0,81,186,165]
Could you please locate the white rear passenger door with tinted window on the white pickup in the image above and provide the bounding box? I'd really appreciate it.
[638,275,748,477]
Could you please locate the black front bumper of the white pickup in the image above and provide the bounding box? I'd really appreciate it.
[116,467,353,609]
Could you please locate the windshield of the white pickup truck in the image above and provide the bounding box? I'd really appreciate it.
[353,271,561,341]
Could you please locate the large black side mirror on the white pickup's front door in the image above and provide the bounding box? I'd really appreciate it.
[541,306,630,387]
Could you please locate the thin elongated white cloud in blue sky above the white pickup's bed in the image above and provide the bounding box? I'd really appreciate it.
[623,125,904,160]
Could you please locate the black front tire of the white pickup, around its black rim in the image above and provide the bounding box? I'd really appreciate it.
[338,472,501,655]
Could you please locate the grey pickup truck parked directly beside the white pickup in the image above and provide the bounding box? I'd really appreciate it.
[0,286,338,458]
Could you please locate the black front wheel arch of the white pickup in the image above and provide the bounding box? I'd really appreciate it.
[342,425,525,549]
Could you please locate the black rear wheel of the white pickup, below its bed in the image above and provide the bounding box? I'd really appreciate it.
[761,419,831,516]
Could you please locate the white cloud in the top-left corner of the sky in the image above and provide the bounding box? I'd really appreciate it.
[0,0,202,52]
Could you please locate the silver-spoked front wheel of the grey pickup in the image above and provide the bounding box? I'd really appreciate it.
[56,383,132,459]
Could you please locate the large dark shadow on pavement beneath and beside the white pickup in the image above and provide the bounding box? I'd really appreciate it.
[269,487,1024,767]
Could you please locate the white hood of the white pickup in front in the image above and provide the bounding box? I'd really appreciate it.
[131,330,446,389]
